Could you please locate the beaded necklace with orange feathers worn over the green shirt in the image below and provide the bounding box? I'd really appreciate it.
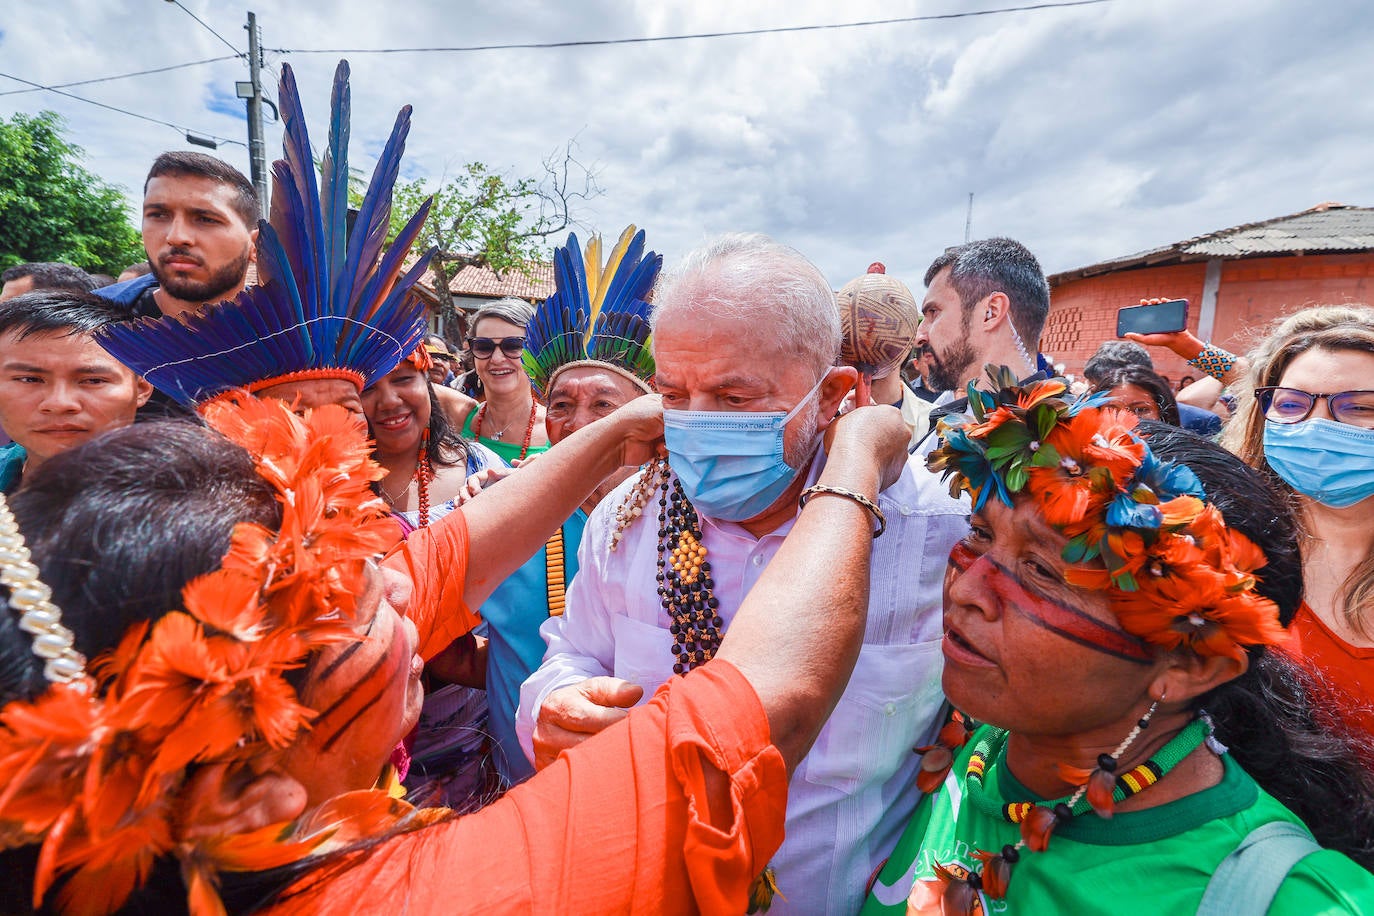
[936,707,1212,912]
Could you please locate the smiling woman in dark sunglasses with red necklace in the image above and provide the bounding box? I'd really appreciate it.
[463,299,548,461]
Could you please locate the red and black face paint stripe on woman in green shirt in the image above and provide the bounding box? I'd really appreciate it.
[949,541,1154,665]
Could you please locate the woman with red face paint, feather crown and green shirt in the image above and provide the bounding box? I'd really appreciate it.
[863,375,1374,916]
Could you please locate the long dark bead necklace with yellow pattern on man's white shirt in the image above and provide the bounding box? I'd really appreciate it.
[654,477,725,674]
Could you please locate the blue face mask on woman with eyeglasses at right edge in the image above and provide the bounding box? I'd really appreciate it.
[1264,416,1374,509]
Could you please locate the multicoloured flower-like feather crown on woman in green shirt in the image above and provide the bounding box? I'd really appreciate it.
[929,365,1285,667]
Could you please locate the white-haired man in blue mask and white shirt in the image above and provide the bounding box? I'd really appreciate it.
[517,235,967,913]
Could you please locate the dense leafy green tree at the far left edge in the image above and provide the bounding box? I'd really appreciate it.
[0,111,146,276]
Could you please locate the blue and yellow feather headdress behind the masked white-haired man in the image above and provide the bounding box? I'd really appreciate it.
[523,225,664,398]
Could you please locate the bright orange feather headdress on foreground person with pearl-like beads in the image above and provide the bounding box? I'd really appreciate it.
[0,396,425,913]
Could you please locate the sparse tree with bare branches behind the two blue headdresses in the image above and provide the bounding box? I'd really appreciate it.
[390,143,600,329]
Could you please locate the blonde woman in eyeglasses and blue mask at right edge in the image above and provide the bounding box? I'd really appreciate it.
[1226,306,1374,733]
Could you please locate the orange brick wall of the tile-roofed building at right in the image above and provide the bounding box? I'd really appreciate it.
[1040,253,1374,383]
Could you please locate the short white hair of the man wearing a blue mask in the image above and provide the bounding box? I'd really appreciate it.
[651,232,841,378]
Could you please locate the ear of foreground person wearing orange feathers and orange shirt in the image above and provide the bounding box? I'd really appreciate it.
[179,764,306,839]
